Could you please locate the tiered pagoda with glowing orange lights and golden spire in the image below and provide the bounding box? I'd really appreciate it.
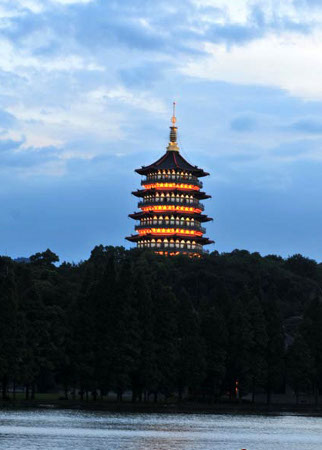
[126,103,213,257]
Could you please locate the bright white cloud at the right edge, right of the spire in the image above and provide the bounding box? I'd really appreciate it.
[181,32,322,100]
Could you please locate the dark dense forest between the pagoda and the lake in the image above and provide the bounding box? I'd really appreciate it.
[0,246,322,403]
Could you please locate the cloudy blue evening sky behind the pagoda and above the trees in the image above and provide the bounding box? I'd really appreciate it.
[0,0,322,262]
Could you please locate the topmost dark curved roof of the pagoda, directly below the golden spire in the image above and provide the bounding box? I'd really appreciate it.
[135,150,209,177]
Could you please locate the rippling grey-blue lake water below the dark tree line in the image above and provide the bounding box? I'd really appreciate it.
[0,410,322,450]
